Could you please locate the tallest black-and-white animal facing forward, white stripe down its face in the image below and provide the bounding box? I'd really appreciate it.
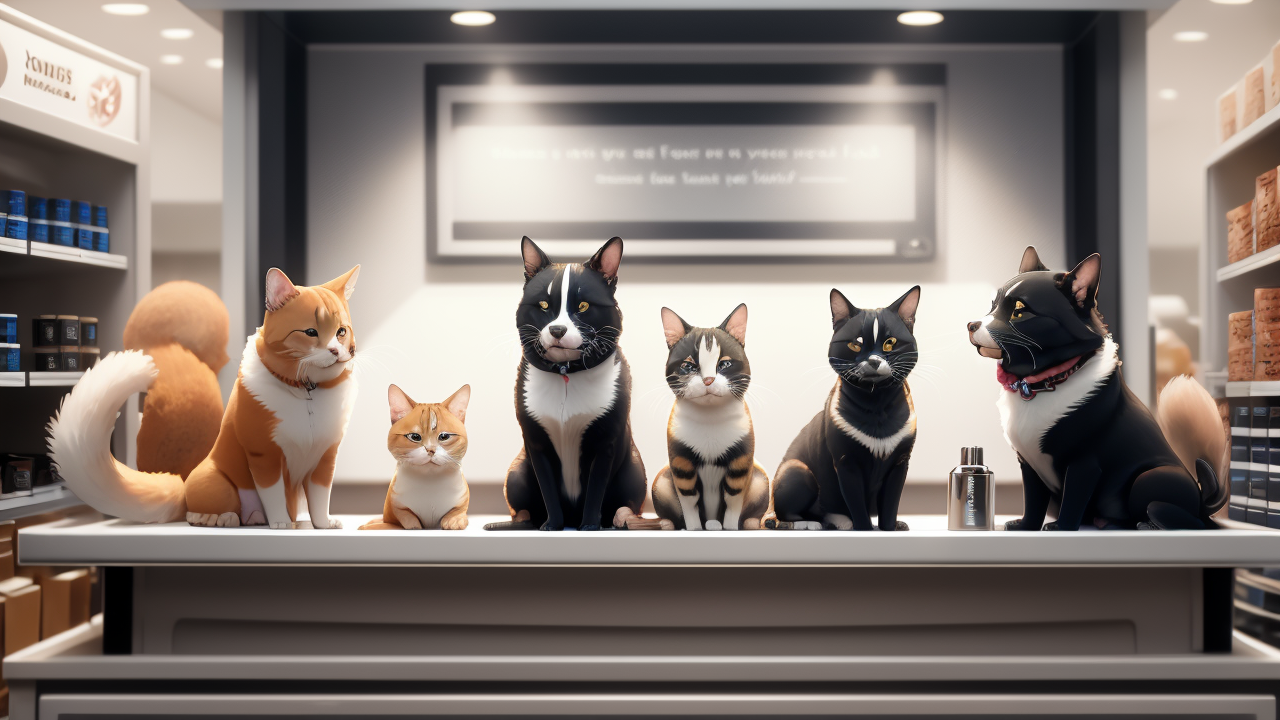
[486,237,646,530]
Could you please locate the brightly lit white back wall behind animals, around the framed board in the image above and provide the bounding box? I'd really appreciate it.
[307,46,1065,483]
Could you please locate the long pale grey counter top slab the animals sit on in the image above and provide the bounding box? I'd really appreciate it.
[18,516,1280,568]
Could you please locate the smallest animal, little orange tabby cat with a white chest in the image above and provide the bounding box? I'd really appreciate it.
[360,386,471,530]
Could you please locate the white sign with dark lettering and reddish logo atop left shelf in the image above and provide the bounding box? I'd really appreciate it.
[0,20,138,141]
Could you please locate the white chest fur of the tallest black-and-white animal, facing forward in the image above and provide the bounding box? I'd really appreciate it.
[524,355,622,500]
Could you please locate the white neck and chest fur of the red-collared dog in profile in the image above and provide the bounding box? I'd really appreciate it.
[996,337,1119,491]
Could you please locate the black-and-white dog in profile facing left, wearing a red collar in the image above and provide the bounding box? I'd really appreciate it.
[969,247,1226,530]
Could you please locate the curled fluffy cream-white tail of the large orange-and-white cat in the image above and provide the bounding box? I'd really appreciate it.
[49,350,187,523]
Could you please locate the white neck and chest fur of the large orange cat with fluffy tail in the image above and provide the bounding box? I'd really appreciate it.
[241,336,356,484]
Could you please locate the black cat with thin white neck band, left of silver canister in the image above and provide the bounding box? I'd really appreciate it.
[765,286,920,530]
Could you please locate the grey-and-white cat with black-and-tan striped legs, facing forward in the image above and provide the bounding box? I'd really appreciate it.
[653,305,769,530]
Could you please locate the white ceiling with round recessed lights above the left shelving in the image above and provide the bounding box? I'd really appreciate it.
[4,0,223,123]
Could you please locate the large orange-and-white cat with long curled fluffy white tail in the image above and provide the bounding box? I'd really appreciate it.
[49,265,360,528]
